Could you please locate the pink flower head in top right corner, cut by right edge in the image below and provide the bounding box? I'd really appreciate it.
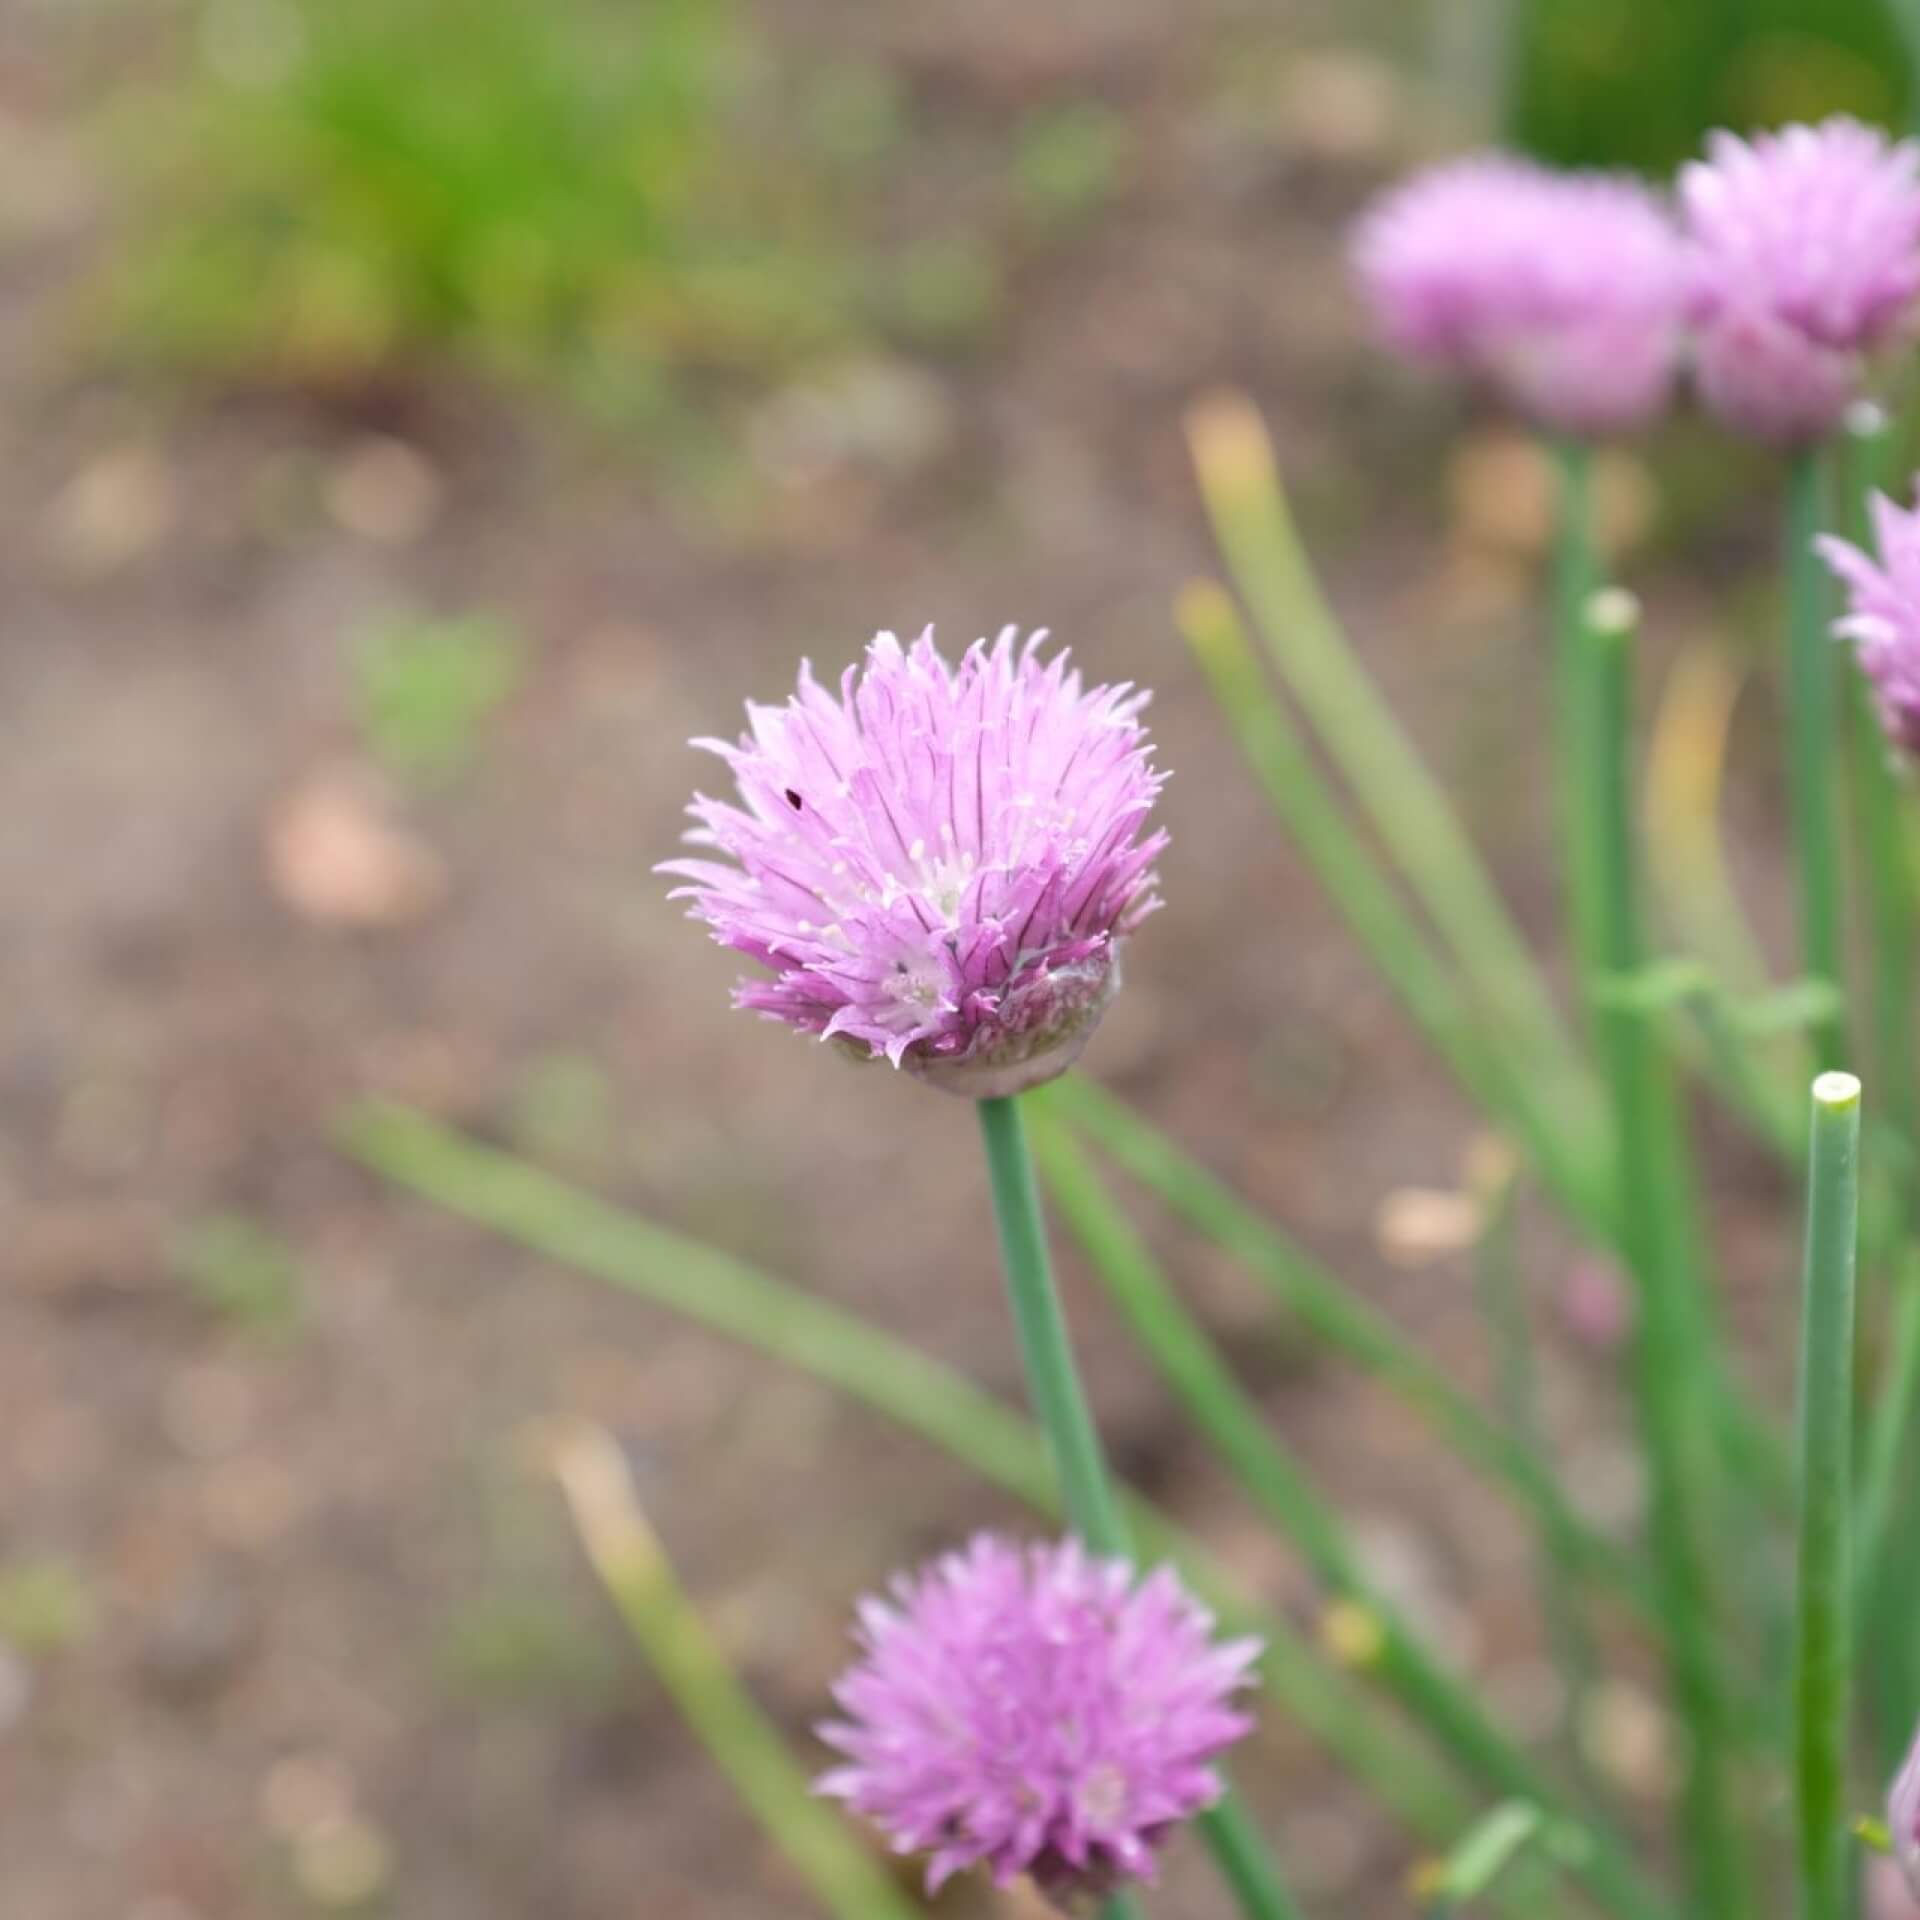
[1680,117,1920,444]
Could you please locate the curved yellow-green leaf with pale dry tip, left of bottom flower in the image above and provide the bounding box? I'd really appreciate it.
[551,1425,922,1920]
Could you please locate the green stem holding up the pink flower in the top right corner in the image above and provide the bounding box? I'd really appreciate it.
[1786,447,1847,1069]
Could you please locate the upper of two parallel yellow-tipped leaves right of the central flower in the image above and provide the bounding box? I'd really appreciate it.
[1190,397,1597,1152]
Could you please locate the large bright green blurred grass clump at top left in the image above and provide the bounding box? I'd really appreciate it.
[109,0,841,399]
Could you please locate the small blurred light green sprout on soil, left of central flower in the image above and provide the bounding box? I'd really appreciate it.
[353,614,526,785]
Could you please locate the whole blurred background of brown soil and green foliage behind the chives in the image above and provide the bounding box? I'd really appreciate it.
[0,0,1920,1920]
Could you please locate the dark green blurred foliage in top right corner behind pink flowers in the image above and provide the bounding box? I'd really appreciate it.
[1509,0,1920,173]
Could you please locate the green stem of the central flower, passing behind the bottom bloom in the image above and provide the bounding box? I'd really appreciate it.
[979,1100,1300,1920]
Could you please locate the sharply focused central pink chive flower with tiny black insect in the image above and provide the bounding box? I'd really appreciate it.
[662,628,1165,1098]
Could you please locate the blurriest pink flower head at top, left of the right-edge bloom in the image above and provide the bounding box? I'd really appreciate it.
[1354,154,1686,434]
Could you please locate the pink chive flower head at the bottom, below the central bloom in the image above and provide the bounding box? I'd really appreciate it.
[820,1536,1260,1905]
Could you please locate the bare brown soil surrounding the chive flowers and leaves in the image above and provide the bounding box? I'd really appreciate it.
[0,0,1812,1920]
